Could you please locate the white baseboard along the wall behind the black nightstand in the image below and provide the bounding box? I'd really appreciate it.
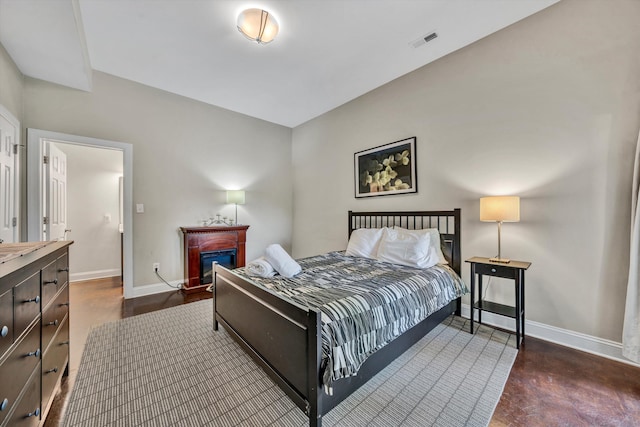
[462,304,640,367]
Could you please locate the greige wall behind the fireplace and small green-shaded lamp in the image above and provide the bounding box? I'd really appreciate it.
[23,72,292,287]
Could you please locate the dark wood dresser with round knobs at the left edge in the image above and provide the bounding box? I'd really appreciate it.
[0,241,73,426]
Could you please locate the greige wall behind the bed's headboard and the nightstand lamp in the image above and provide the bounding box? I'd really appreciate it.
[292,0,640,342]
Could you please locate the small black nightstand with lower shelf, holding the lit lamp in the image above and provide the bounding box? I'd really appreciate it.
[466,257,531,348]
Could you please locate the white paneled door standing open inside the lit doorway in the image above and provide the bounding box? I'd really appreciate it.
[44,141,67,240]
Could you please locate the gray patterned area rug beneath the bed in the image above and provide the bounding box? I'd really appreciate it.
[62,300,517,427]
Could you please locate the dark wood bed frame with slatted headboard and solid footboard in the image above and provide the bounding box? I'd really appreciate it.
[213,209,461,427]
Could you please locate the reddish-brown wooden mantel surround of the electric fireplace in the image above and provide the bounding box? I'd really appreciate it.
[180,225,249,293]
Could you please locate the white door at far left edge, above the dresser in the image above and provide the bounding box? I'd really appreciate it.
[0,111,18,243]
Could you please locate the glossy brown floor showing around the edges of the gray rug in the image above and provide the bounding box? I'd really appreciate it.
[45,278,640,427]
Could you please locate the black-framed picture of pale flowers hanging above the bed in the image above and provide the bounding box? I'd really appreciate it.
[354,136,418,198]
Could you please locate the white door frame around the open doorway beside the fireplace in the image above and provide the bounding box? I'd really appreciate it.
[27,128,135,298]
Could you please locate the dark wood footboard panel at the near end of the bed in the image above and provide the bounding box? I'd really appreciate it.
[213,264,322,425]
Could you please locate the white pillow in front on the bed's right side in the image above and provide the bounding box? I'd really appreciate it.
[377,228,438,268]
